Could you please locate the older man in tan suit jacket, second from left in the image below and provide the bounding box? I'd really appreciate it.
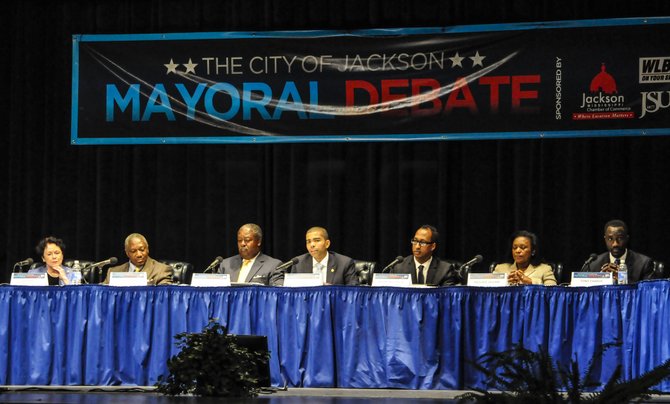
[104,233,172,285]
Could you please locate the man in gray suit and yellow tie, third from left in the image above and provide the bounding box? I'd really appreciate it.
[218,223,281,284]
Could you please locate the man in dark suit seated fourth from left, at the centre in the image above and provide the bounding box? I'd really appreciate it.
[273,227,358,285]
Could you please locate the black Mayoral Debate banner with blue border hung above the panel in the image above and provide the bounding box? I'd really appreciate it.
[72,18,670,144]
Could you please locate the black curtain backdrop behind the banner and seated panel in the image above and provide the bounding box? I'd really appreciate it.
[0,0,670,281]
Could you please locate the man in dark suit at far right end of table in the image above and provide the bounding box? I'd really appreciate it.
[589,220,654,283]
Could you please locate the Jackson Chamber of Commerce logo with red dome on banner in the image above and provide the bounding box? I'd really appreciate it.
[572,63,635,121]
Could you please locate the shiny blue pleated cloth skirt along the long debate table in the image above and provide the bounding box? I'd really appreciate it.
[0,280,670,392]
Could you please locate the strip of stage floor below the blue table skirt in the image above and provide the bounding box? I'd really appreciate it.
[0,386,670,404]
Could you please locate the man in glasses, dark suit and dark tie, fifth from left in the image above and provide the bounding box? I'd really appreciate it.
[391,225,459,286]
